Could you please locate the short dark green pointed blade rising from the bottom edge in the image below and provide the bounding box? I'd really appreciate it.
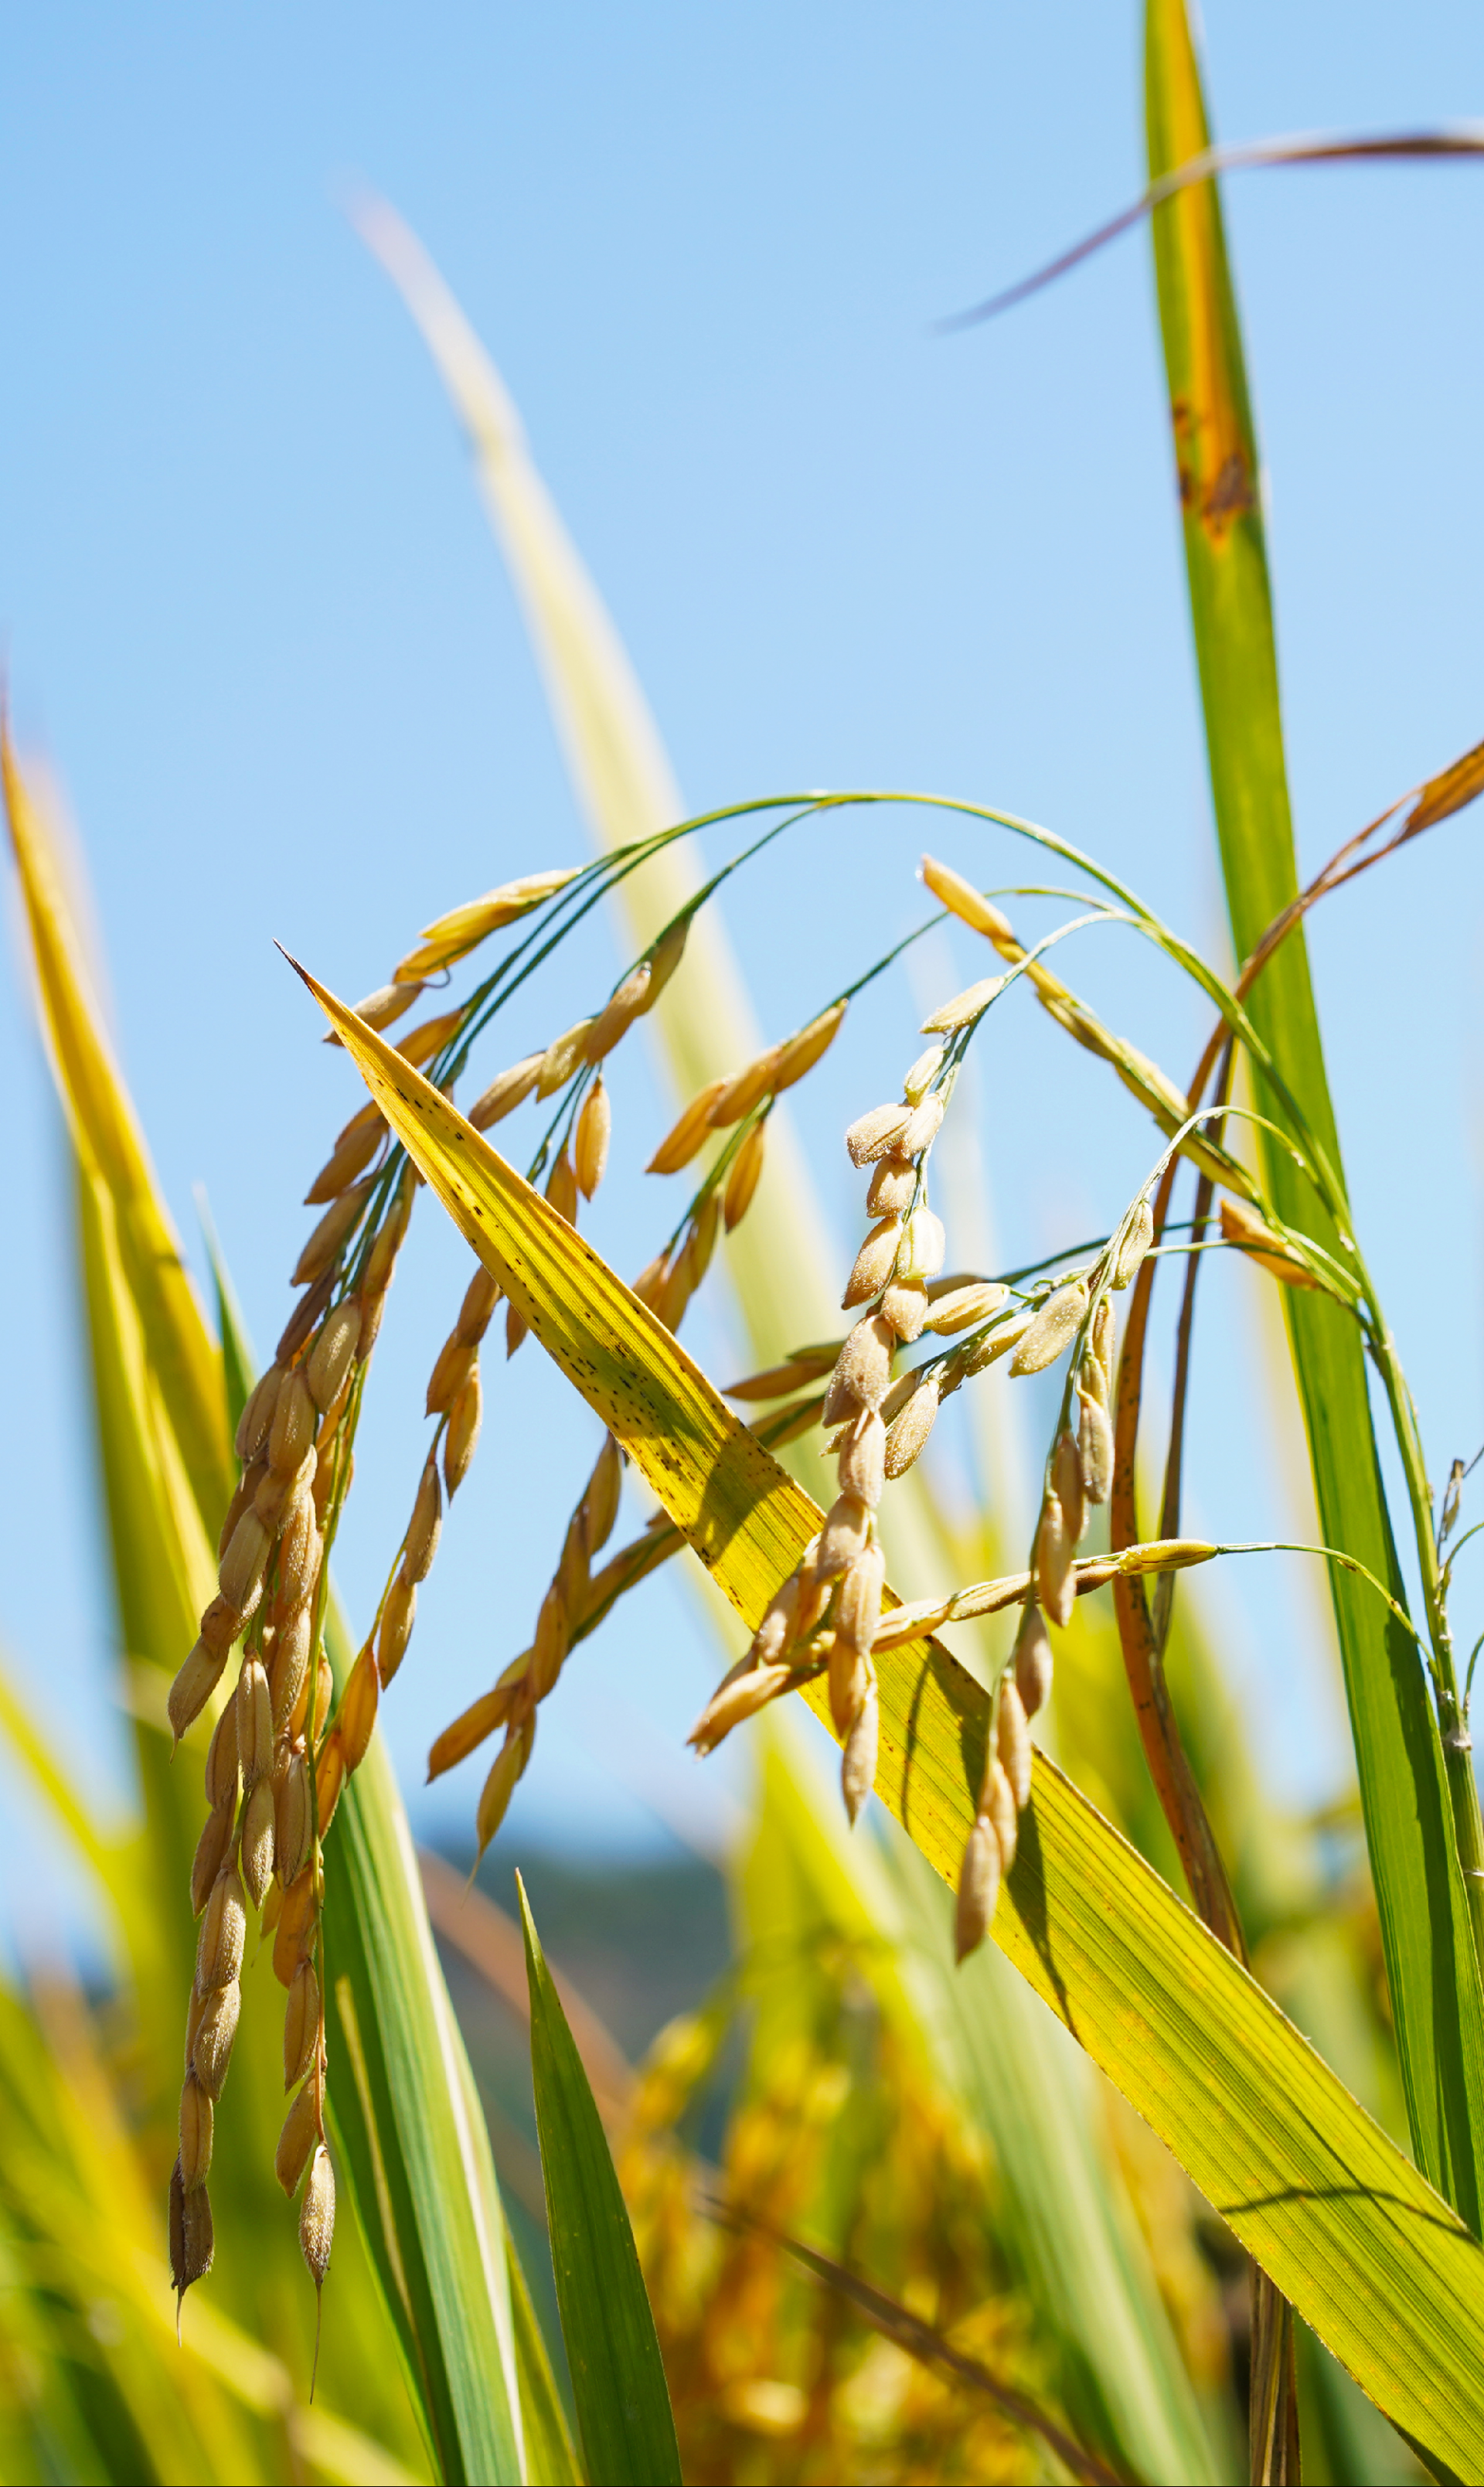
[515,1875,681,2487]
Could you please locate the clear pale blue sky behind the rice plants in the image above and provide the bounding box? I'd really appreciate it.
[0,0,1484,1959]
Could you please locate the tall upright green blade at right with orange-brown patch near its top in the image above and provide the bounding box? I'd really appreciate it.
[1146,0,1484,2231]
